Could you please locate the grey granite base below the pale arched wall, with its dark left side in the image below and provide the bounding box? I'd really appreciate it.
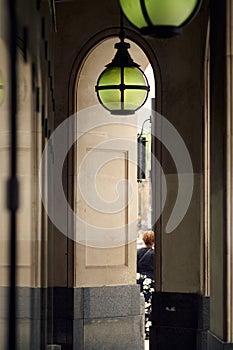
[53,285,144,350]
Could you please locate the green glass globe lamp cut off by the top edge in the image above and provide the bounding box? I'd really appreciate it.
[119,0,202,38]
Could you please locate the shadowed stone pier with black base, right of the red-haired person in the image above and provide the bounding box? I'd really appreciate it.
[150,2,209,350]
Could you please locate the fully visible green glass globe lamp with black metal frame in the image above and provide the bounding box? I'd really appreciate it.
[95,15,150,115]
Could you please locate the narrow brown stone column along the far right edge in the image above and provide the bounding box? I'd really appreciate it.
[208,0,233,350]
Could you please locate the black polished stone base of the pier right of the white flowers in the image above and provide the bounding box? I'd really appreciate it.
[150,292,212,350]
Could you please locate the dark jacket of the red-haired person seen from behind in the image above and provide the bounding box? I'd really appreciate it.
[137,247,154,275]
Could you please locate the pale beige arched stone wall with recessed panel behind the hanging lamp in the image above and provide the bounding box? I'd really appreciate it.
[70,34,155,348]
